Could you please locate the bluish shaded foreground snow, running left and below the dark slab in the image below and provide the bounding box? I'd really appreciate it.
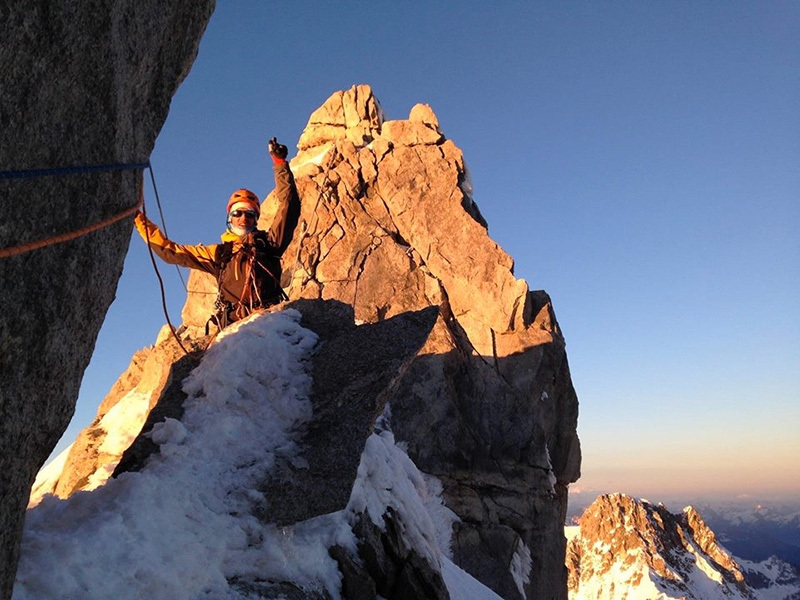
[13,310,498,600]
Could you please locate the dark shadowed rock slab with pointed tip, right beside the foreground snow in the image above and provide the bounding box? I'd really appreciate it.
[262,300,438,525]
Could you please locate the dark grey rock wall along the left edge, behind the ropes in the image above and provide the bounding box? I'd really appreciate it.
[0,0,214,598]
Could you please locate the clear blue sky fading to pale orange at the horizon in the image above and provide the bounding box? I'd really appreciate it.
[53,0,800,500]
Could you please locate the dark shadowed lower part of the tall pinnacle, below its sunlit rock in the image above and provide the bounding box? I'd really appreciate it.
[390,298,579,599]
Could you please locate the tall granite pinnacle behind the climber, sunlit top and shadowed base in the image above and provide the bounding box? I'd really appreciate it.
[284,86,580,598]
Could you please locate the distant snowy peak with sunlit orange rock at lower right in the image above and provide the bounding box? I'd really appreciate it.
[566,494,800,600]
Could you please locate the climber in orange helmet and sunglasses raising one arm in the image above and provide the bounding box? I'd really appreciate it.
[134,138,300,330]
